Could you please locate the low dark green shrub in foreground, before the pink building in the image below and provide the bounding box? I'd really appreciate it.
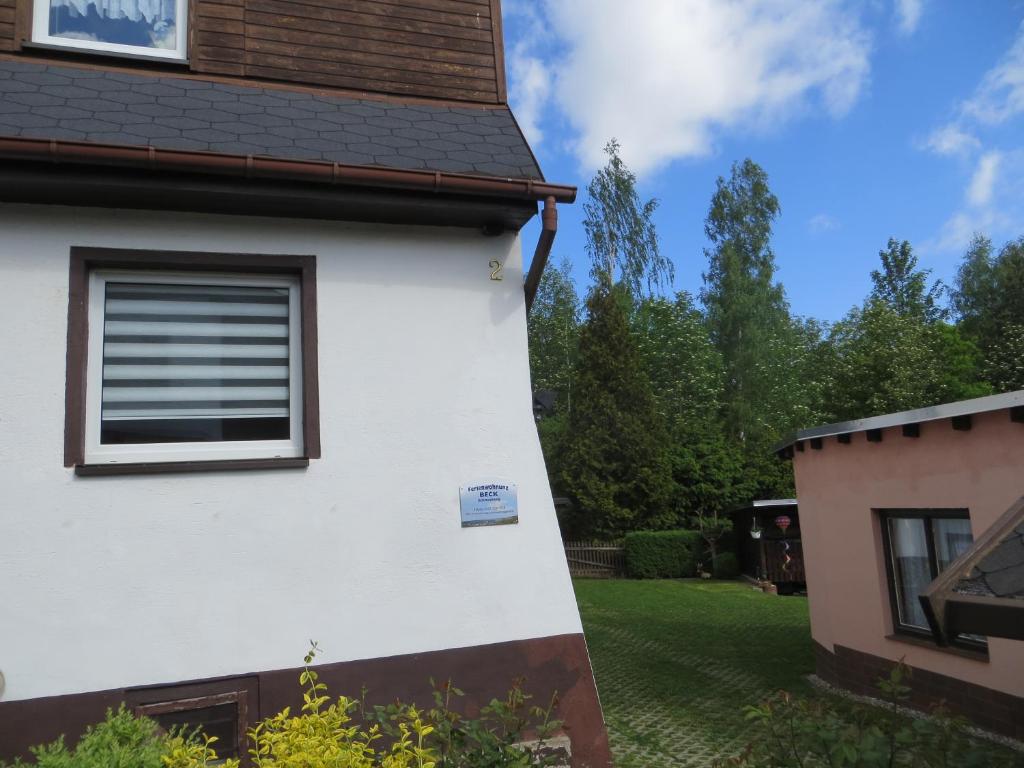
[713,663,1019,768]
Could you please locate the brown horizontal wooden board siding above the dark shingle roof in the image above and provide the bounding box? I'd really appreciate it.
[0,0,505,103]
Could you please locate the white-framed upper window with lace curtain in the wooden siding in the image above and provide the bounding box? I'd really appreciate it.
[32,0,188,59]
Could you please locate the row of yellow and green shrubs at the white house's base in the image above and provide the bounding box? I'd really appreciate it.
[6,643,564,768]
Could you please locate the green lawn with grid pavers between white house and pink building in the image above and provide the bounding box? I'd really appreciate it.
[574,580,814,768]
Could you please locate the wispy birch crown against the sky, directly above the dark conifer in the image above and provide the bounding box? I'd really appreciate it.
[583,139,673,297]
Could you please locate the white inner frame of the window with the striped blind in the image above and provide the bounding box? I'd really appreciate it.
[85,269,304,464]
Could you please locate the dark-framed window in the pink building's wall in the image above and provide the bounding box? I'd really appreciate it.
[879,509,986,650]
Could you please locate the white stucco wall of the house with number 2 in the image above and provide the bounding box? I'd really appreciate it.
[0,205,581,700]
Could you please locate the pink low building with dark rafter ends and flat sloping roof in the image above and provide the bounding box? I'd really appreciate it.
[779,391,1024,739]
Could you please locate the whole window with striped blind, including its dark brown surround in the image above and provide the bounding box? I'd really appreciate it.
[65,248,319,474]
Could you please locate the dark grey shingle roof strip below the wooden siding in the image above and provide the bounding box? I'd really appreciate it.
[0,60,543,179]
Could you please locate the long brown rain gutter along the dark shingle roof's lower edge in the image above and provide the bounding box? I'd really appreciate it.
[0,136,577,203]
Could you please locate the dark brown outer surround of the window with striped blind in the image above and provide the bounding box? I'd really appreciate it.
[63,246,321,476]
